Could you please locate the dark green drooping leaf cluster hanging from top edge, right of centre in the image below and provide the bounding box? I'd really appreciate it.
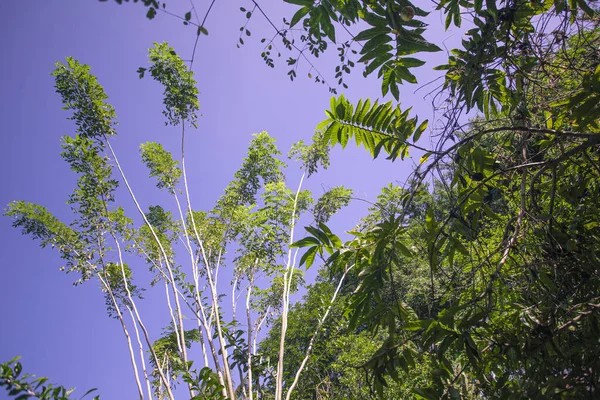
[282,0,441,100]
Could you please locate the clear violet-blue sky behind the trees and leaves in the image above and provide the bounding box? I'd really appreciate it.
[0,0,460,399]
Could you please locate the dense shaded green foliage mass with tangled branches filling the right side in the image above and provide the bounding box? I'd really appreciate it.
[290,6,600,399]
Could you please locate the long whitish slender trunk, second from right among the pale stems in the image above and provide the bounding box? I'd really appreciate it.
[275,173,306,400]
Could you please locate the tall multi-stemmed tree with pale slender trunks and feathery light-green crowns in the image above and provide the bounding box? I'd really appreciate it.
[2,43,350,399]
